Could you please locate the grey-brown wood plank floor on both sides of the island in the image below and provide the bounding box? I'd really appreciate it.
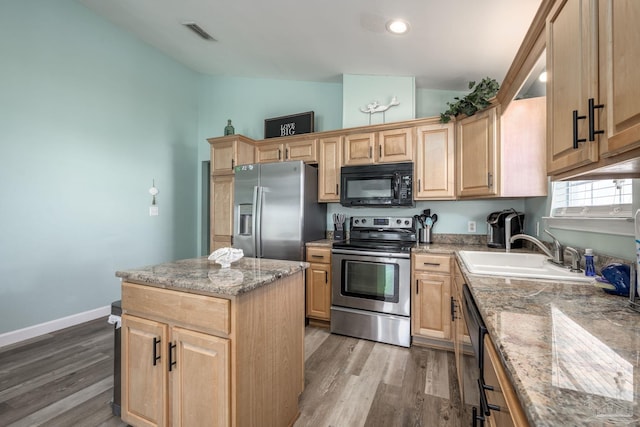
[0,319,475,427]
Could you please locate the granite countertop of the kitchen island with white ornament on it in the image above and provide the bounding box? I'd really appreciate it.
[116,256,309,297]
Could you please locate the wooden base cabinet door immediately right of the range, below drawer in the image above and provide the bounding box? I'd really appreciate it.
[412,273,451,340]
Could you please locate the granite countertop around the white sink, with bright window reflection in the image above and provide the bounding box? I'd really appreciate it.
[459,252,640,426]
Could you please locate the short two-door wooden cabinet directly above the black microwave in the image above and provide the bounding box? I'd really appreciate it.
[343,127,413,166]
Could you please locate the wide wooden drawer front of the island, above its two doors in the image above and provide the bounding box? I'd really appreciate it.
[122,282,231,335]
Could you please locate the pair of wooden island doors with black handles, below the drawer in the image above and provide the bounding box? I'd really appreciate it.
[122,315,230,426]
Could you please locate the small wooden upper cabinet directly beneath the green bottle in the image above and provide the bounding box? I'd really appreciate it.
[207,135,254,175]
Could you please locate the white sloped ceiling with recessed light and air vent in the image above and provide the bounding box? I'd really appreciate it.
[78,0,541,90]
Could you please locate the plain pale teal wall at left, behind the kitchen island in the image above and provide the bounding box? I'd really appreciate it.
[0,0,198,333]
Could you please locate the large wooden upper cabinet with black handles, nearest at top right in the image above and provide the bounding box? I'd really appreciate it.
[547,0,640,179]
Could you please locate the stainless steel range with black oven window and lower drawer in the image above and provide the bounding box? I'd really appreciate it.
[331,217,416,347]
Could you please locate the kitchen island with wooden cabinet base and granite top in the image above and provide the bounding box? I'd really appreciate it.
[116,257,308,426]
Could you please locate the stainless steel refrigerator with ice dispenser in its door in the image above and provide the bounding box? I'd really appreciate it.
[233,161,327,261]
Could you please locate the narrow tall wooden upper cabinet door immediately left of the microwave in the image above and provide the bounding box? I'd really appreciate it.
[318,136,342,202]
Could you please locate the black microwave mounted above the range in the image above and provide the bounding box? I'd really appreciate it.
[340,162,414,207]
